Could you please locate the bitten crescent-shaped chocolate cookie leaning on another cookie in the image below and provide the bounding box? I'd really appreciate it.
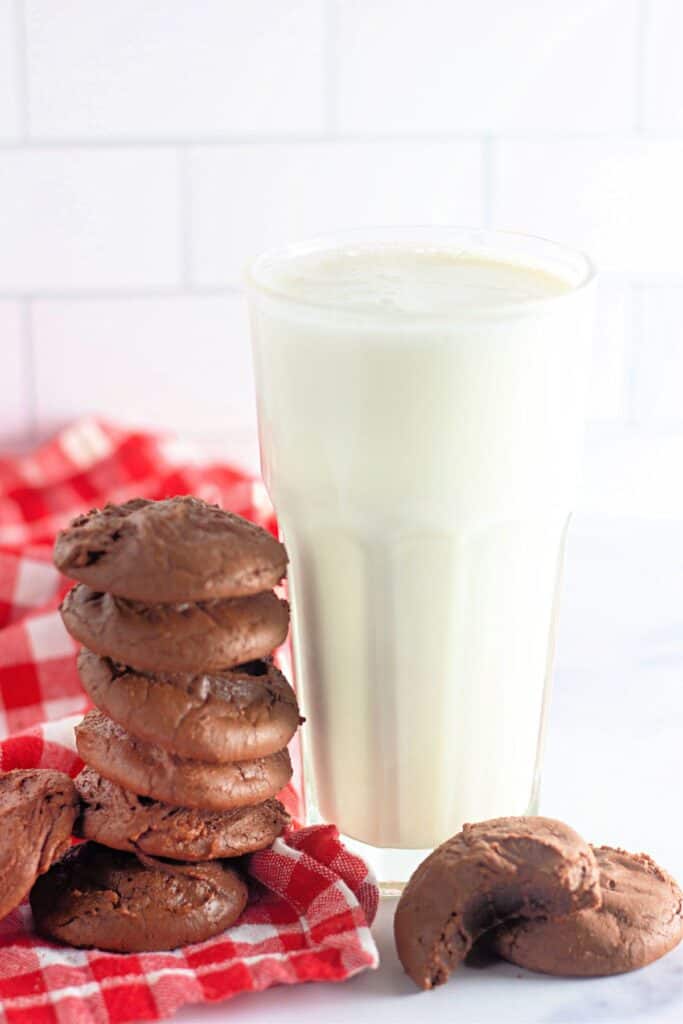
[394,817,600,988]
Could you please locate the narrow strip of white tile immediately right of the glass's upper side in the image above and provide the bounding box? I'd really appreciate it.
[588,274,633,420]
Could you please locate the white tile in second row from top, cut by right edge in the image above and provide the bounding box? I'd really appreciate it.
[494,139,683,272]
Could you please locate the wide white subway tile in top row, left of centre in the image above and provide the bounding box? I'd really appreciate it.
[27,0,325,139]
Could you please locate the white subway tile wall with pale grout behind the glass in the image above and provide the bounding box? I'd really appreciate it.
[0,0,683,512]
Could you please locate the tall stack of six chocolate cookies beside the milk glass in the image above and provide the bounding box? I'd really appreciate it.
[40,498,300,951]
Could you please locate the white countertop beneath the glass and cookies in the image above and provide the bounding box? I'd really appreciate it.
[174,517,683,1024]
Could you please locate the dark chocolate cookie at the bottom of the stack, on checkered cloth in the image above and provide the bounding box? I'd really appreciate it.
[31,843,248,953]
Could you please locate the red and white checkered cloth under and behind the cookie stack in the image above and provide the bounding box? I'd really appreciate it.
[0,420,379,1024]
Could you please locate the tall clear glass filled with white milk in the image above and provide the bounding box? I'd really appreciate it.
[249,227,594,882]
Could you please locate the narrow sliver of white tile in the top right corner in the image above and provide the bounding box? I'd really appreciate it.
[643,0,683,135]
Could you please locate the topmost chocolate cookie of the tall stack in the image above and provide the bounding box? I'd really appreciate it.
[54,497,287,603]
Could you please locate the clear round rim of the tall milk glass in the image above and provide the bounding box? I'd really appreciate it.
[245,224,597,327]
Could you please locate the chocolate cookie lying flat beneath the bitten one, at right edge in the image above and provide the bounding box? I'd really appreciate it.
[486,846,683,978]
